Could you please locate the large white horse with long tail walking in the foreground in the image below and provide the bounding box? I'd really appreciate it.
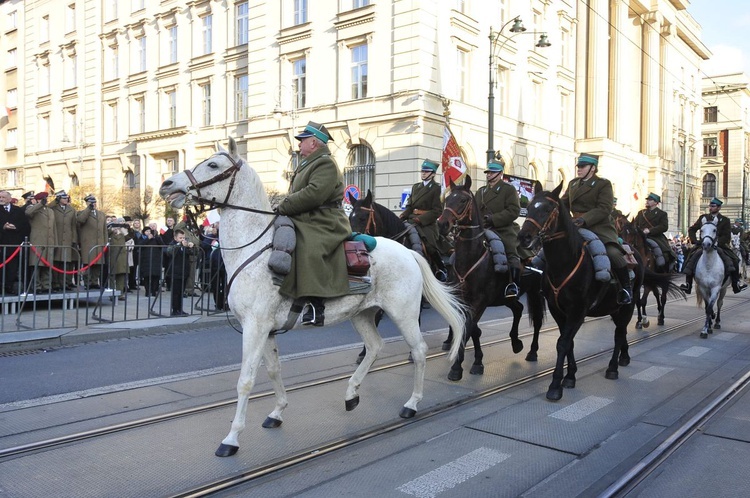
[159,138,464,456]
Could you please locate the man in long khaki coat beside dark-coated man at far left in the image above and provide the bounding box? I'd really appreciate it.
[25,192,57,292]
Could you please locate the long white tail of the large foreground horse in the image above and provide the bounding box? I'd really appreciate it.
[409,251,468,362]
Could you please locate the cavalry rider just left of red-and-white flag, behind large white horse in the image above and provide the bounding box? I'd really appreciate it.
[399,159,448,282]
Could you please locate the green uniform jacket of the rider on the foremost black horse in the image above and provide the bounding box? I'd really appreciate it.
[562,175,620,248]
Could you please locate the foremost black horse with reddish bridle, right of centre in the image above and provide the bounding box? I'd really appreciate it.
[519,183,679,401]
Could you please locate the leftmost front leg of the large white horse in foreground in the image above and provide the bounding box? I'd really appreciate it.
[216,326,268,456]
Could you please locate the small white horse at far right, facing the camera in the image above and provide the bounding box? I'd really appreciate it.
[694,218,729,339]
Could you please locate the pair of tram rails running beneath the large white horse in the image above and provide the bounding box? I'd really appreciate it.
[0,303,743,497]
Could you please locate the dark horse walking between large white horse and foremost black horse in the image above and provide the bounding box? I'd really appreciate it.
[438,177,545,380]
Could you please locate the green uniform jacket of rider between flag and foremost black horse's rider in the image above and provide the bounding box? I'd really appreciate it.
[476,180,521,257]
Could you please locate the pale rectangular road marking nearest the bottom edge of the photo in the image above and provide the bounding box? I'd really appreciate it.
[396,447,510,498]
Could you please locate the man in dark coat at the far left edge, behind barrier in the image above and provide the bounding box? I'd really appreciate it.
[0,190,31,294]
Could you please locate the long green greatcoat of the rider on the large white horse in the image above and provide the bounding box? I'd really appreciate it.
[279,146,352,299]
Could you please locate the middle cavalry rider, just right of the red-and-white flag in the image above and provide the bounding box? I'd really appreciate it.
[476,158,521,298]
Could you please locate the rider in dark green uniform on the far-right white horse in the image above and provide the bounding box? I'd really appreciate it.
[680,197,747,294]
